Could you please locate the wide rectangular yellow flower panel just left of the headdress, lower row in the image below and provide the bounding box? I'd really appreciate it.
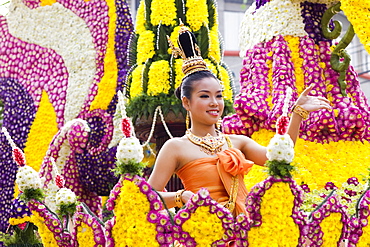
[147,60,171,96]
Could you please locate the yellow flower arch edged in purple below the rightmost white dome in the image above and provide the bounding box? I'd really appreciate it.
[246,176,304,246]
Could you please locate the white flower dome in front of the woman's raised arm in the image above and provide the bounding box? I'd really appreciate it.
[266,134,294,163]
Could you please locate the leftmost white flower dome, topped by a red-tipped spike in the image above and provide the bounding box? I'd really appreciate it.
[15,166,42,191]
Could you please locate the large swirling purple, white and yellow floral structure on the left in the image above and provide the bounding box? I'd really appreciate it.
[0,0,133,235]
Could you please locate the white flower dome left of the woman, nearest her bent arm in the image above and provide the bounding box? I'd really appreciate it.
[116,137,144,163]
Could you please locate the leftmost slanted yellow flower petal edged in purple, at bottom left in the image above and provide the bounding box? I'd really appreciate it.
[28,200,72,247]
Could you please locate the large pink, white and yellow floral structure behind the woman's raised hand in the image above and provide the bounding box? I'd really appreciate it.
[223,0,370,192]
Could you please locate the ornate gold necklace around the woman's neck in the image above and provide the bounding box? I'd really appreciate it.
[186,129,226,155]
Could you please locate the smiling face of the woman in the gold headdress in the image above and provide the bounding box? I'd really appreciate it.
[183,77,224,125]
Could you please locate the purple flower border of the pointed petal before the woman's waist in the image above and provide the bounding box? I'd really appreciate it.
[173,188,234,247]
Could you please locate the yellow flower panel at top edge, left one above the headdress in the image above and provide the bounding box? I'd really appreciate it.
[150,0,177,26]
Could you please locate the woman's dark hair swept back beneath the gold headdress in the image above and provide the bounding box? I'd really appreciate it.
[175,70,218,100]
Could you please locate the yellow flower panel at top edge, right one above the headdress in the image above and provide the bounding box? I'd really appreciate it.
[186,0,208,32]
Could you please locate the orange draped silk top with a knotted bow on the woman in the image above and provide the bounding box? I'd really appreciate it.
[176,148,253,216]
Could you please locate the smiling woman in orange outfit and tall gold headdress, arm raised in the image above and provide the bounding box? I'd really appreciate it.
[149,28,330,215]
